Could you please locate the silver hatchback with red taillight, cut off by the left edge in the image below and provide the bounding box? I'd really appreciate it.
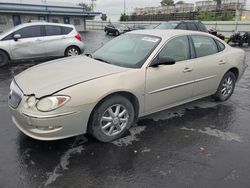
[0,22,84,66]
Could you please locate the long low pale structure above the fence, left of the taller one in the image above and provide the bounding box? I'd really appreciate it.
[133,3,194,15]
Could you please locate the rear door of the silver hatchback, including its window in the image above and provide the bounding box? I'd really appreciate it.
[42,25,73,57]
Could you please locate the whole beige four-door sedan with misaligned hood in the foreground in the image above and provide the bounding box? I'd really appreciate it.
[9,30,247,142]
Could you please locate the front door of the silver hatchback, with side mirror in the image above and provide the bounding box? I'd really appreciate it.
[9,25,46,59]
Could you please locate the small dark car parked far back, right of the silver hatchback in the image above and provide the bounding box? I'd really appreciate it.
[104,24,131,36]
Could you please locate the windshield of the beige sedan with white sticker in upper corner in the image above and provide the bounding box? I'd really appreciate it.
[91,34,161,68]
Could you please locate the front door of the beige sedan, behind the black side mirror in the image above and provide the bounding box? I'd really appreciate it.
[144,36,193,113]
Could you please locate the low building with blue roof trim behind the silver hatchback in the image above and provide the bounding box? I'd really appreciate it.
[0,0,100,32]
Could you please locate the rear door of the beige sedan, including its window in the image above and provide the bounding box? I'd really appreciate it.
[191,35,226,96]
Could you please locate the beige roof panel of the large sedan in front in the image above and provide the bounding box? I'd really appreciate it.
[129,29,211,39]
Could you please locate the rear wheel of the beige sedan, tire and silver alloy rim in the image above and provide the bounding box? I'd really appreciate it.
[213,72,236,102]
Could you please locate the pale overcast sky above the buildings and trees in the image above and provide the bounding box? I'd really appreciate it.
[10,0,250,21]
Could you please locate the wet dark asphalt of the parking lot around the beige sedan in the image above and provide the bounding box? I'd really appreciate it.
[0,32,250,188]
